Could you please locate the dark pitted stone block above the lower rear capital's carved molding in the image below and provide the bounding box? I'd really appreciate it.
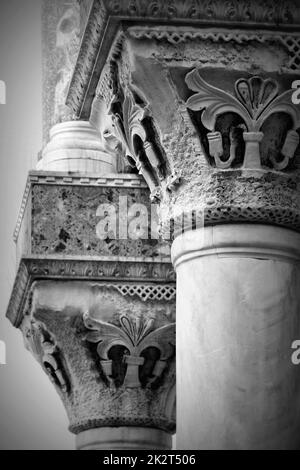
[16,172,170,260]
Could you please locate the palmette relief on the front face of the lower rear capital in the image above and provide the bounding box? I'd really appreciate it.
[83,313,175,388]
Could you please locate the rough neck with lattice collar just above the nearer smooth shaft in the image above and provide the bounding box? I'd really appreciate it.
[160,170,300,234]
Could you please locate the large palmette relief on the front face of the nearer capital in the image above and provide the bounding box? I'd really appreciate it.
[186,69,300,170]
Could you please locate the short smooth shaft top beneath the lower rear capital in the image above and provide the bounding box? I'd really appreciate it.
[76,426,172,450]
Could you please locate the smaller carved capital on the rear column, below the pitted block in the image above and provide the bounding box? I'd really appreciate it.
[20,280,175,434]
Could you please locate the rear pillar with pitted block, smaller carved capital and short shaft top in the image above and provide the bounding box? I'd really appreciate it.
[7,171,176,450]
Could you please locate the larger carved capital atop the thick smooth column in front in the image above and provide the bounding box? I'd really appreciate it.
[69,16,300,238]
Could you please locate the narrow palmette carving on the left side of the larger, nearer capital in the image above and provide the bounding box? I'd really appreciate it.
[97,57,182,197]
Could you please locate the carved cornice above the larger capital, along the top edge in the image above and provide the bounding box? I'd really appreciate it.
[66,0,300,119]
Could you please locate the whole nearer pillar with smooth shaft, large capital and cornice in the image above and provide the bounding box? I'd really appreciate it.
[67,0,300,449]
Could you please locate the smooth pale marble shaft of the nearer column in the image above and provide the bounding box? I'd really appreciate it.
[172,224,300,449]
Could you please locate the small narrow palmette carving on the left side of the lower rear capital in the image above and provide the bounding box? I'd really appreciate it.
[22,317,70,393]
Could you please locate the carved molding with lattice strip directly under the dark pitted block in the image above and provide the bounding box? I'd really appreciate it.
[6,257,176,327]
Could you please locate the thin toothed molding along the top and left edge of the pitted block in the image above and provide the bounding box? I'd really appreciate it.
[13,171,148,242]
